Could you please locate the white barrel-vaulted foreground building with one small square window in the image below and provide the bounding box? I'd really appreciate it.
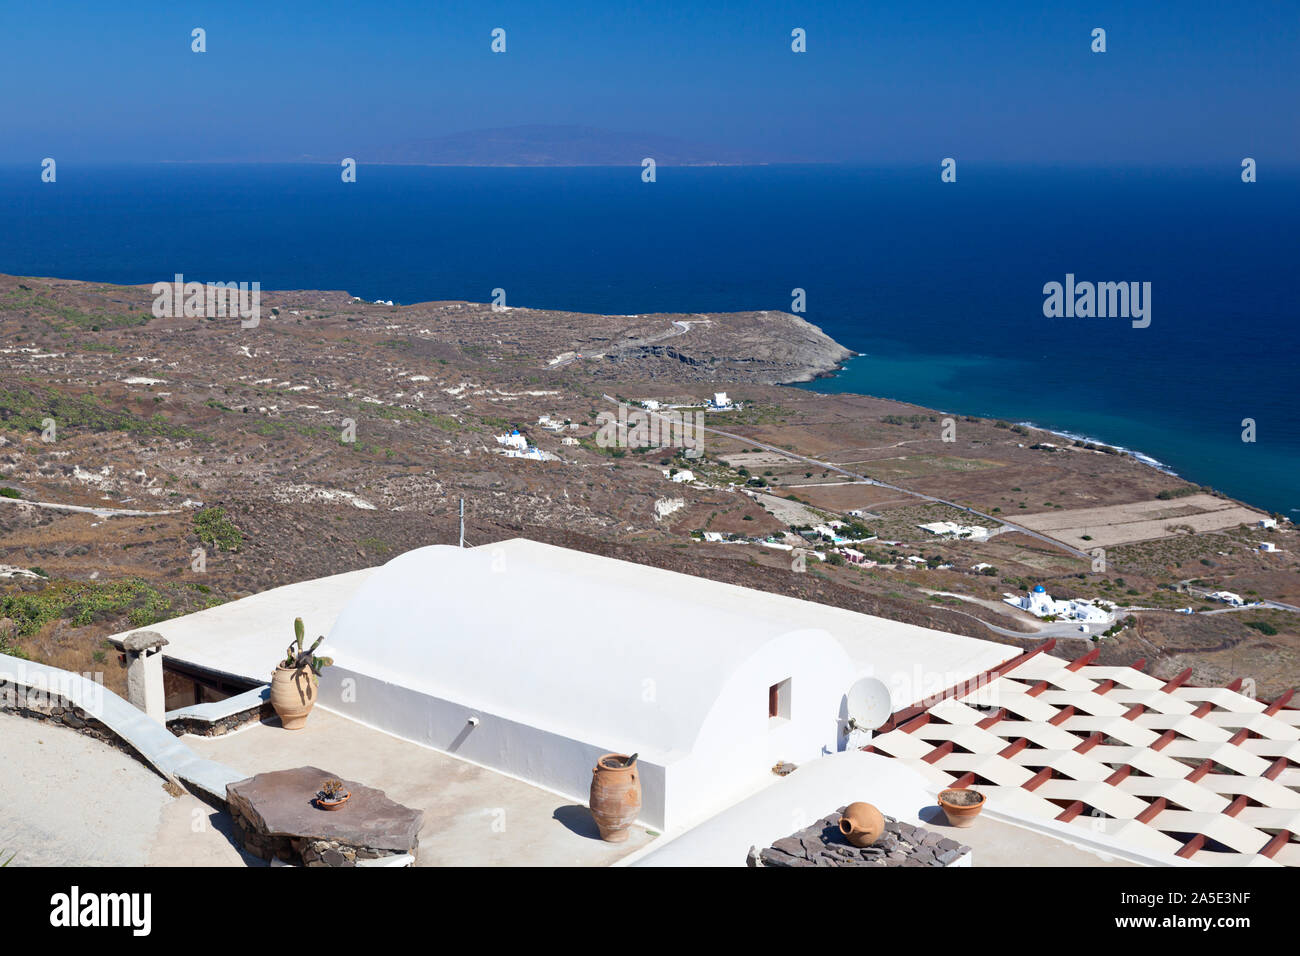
[320,540,1013,829]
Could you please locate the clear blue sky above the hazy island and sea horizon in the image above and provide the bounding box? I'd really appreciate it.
[0,0,1300,165]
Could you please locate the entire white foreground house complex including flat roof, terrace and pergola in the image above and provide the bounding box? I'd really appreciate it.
[68,540,1300,866]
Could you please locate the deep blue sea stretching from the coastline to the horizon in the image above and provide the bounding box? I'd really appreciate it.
[0,163,1300,515]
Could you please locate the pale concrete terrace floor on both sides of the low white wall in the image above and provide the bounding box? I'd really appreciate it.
[0,709,653,866]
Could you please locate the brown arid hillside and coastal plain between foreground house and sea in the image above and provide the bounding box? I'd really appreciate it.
[0,276,1300,697]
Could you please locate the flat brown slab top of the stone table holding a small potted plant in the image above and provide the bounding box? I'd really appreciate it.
[226,767,424,853]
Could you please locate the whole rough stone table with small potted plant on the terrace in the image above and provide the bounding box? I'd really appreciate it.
[226,767,424,866]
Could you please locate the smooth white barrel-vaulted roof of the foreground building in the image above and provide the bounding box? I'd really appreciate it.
[326,538,1011,754]
